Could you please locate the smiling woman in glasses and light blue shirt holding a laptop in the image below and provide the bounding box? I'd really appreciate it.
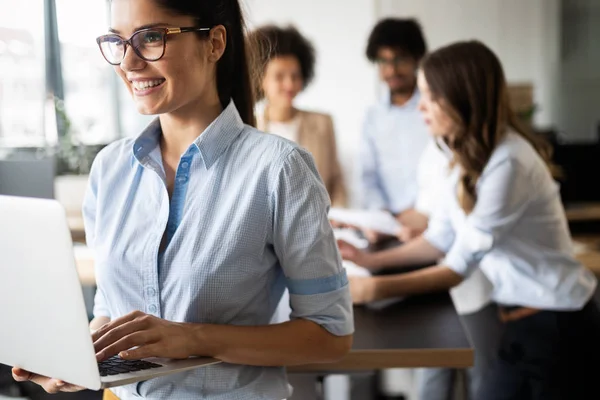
[13,0,353,400]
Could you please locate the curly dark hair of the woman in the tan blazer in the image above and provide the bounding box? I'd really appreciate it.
[250,25,315,97]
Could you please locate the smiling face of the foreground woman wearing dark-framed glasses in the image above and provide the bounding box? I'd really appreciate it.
[111,0,222,114]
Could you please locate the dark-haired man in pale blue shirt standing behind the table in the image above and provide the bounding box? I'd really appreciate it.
[360,18,429,241]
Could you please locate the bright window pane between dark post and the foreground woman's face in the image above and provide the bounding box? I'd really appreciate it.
[56,0,121,144]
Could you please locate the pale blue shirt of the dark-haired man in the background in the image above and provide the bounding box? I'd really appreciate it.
[359,90,430,213]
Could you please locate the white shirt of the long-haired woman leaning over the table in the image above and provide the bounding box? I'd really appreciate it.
[424,133,596,310]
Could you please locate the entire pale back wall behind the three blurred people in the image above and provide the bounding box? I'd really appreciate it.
[245,0,600,206]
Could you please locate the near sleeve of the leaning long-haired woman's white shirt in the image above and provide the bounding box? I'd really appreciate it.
[444,159,535,277]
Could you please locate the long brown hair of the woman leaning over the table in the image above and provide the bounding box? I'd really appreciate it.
[422,41,555,214]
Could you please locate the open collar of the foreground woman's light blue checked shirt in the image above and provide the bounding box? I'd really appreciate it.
[132,100,244,169]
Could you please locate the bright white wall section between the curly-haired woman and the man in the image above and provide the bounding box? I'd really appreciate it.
[245,0,377,205]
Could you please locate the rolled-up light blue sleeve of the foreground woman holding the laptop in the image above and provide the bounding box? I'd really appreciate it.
[270,149,354,336]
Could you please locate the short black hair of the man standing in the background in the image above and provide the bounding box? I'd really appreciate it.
[367,18,427,62]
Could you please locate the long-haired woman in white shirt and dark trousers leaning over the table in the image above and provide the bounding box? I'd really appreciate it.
[339,41,600,400]
